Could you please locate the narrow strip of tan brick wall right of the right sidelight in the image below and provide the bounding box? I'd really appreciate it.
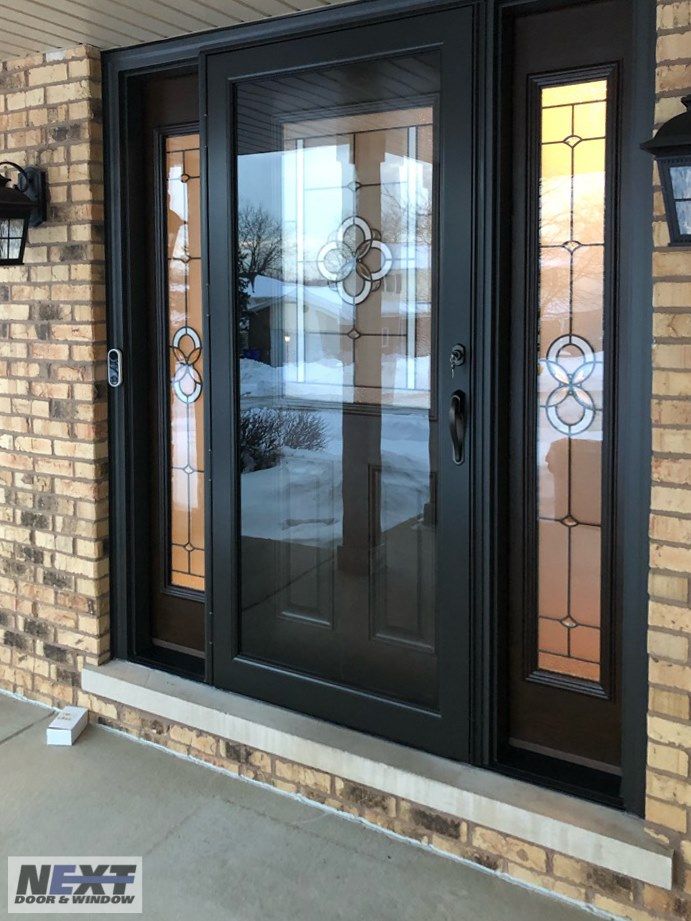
[646,0,691,917]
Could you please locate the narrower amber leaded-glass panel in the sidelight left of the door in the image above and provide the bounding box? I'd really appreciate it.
[165,134,204,591]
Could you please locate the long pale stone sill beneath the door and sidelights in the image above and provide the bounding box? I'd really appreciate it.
[82,660,672,889]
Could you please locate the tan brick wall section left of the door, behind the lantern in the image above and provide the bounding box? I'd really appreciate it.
[0,47,108,703]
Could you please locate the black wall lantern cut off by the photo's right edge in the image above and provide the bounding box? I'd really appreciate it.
[641,96,691,246]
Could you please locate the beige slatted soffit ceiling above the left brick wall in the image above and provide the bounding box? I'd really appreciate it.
[0,0,338,60]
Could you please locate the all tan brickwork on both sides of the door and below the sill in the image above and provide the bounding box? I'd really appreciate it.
[0,0,691,921]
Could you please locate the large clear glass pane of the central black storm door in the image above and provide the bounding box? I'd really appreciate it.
[236,53,438,705]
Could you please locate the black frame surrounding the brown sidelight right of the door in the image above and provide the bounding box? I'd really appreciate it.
[478,0,655,815]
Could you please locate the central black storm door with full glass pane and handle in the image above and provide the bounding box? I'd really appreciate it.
[206,9,473,758]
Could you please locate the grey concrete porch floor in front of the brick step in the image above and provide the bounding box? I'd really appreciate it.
[0,695,592,921]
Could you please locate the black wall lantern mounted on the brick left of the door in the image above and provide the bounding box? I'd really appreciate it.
[0,160,46,266]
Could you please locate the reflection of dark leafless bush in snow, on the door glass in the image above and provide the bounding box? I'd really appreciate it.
[240,408,326,473]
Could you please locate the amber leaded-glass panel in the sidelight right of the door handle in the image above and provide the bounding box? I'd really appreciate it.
[537,80,607,681]
